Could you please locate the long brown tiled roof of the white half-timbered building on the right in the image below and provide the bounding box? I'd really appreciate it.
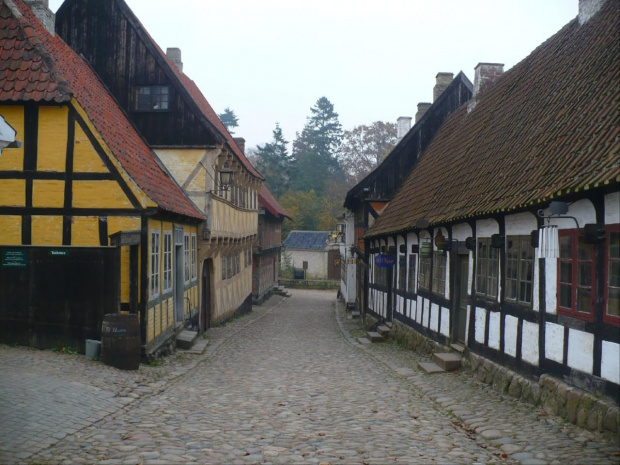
[367,0,620,237]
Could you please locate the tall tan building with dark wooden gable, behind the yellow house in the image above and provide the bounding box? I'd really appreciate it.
[56,0,263,330]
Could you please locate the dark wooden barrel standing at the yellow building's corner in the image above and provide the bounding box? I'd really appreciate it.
[101,313,141,370]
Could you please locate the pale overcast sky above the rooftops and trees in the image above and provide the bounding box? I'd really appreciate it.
[49,0,578,148]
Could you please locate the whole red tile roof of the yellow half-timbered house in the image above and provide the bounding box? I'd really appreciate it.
[0,0,204,219]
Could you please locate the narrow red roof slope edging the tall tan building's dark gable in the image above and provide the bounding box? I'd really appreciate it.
[116,0,264,179]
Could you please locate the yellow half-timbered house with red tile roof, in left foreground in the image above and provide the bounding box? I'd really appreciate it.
[0,0,205,356]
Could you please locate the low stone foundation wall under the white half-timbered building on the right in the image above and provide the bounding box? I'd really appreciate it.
[386,315,620,434]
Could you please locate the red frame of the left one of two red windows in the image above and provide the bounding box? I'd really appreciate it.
[556,229,596,321]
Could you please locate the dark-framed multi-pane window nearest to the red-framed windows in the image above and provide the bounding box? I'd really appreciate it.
[505,236,534,305]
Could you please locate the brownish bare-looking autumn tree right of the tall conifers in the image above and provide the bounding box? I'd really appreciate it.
[340,121,397,187]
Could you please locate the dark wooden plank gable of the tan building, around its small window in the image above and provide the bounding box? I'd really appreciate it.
[56,0,224,147]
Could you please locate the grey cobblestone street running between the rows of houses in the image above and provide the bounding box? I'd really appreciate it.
[0,290,620,465]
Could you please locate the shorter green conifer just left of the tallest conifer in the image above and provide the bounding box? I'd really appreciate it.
[255,123,294,198]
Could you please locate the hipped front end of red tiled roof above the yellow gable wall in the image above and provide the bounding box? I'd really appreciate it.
[0,3,71,103]
